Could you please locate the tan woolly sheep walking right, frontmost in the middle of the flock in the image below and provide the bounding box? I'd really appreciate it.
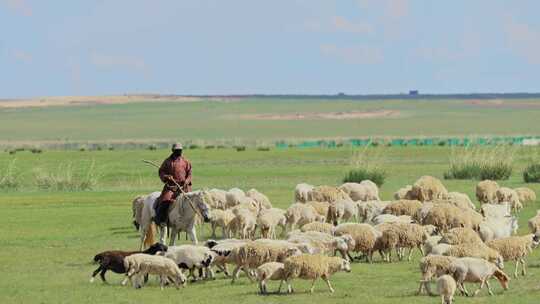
[284,254,351,293]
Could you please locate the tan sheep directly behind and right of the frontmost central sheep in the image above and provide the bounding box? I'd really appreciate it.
[335,223,382,263]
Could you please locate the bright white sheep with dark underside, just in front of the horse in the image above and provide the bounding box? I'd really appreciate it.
[163,245,217,280]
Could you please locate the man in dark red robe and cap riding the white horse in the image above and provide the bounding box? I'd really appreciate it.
[154,143,191,225]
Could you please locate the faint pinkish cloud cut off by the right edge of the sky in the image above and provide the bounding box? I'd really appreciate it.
[504,20,540,64]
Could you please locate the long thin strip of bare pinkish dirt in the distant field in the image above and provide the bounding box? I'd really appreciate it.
[237,110,400,120]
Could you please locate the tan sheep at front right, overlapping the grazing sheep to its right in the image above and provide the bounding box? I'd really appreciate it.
[417,255,456,295]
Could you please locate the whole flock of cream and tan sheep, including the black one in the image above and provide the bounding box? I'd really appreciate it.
[92,176,540,303]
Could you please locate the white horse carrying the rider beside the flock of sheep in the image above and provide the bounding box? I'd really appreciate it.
[139,191,210,250]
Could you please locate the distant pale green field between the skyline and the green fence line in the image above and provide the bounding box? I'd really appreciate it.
[0,98,540,144]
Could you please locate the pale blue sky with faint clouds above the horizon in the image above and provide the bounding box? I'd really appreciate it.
[0,0,540,98]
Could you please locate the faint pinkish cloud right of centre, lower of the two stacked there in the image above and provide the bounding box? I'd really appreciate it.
[320,44,383,64]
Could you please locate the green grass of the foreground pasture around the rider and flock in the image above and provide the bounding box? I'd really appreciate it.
[0,146,540,303]
